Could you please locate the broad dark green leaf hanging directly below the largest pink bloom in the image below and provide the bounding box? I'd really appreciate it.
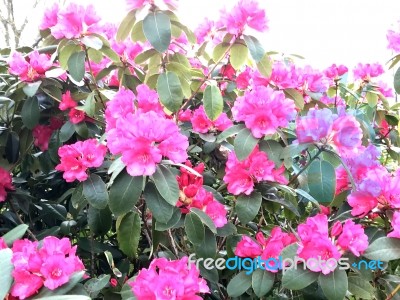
[108,171,143,216]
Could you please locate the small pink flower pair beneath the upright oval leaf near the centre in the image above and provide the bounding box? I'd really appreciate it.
[191,105,233,133]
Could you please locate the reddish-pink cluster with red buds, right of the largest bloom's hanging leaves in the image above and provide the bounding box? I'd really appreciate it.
[176,161,228,228]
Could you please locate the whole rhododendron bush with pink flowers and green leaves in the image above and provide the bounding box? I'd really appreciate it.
[0,0,400,300]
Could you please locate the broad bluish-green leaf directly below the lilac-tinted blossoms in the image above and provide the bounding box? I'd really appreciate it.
[307,159,336,203]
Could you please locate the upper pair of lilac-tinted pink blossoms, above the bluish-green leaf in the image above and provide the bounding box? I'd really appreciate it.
[296,108,363,157]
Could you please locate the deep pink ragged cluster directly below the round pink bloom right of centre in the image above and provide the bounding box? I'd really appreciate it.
[224,146,288,195]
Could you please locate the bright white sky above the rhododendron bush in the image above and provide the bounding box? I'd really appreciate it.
[8,0,400,77]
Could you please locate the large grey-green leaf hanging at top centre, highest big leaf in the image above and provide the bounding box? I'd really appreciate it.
[143,11,171,53]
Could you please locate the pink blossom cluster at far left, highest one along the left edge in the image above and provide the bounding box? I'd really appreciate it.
[8,51,53,82]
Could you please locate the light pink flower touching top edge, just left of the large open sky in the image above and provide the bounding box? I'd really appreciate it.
[221,0,268,35]
